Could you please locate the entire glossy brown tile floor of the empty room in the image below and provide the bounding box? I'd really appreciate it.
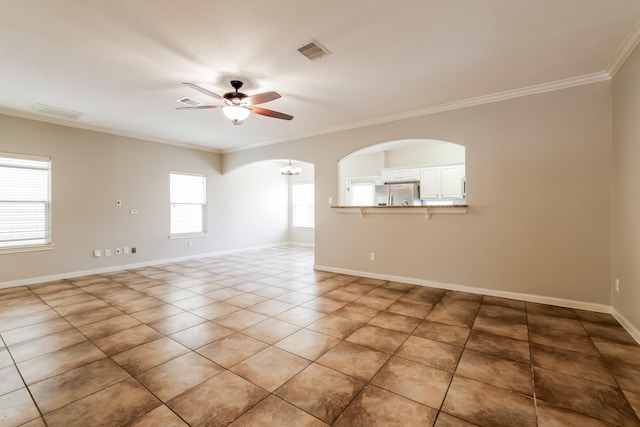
[0,247,640,427]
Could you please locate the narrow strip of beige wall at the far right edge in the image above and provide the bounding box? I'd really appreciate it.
[612,49,640,339]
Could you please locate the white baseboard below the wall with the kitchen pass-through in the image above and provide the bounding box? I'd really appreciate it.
[314,265,611,313]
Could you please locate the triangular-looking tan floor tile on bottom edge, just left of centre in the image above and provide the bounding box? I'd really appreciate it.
[229,395,329,427]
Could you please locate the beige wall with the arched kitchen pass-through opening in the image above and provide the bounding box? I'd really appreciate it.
[222,81,612,305]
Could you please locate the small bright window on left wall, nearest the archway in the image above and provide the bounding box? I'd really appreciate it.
[169,172,207,236]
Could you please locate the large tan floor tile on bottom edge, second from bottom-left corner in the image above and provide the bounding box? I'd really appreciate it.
[44,379,160,427]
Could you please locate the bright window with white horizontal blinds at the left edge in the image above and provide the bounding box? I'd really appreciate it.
[0,153,51,252]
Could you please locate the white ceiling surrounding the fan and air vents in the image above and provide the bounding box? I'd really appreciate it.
[0,0,640,151]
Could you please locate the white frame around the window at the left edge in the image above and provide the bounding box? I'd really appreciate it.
[0,152,54,254]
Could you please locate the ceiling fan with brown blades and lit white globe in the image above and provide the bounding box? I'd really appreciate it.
[177,80,293,125]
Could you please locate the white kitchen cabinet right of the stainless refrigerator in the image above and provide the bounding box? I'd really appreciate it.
[420,165,465,200]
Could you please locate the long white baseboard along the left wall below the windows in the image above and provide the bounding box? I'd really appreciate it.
[0,242,290,289]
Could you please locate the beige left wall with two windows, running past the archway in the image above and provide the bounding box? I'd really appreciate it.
[0,115,288,286]
